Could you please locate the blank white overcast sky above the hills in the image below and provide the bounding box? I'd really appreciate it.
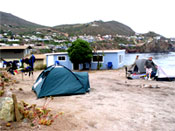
[0,0,175,38]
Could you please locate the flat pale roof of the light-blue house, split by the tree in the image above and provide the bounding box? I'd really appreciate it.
[45,50,125,56]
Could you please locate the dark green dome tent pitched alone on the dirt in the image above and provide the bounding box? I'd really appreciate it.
[32,65,90,98]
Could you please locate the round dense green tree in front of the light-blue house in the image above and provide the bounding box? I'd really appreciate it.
[68,39,93,69]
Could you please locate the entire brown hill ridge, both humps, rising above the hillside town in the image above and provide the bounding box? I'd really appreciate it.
[0,11,135,36]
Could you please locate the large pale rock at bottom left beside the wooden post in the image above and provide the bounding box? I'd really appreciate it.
[0,97,14,122]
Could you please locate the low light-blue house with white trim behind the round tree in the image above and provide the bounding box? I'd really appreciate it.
[46,50,125,70]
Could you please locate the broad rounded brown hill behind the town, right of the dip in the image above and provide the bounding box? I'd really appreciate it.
[53,21,135,36]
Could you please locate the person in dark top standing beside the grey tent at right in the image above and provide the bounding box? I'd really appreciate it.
[145,57,157,80]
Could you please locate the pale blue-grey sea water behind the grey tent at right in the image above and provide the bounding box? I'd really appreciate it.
[125,52,175,76]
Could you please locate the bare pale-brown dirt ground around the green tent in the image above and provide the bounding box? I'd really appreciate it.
[1,69,175,131]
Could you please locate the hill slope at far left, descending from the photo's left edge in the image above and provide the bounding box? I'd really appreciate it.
[0,11,45,33]
